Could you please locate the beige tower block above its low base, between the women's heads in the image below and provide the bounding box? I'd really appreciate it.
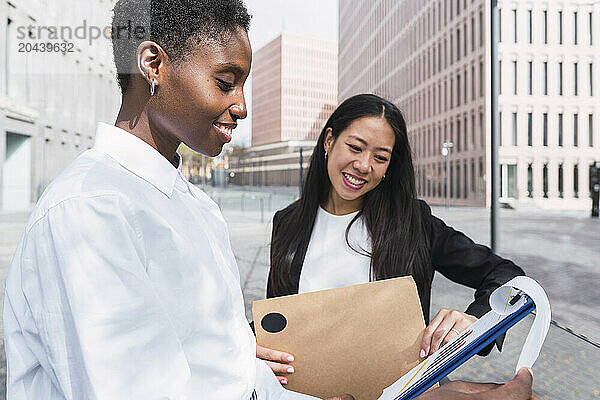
[252,33,337,146]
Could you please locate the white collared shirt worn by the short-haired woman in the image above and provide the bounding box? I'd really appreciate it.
[4,124,314,400]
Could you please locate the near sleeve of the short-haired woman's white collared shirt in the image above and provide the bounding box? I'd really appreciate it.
[5,195,190,400]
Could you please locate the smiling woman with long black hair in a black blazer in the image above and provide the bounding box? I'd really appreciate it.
[258,94,524,388]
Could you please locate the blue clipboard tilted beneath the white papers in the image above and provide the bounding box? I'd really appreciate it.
[395,299,535,400]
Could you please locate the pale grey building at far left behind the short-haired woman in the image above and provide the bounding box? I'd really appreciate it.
[0,0,119,211]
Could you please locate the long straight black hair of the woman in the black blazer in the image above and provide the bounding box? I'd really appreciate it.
[269,94,432,296]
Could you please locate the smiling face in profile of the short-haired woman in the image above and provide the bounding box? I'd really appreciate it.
[148,28,252,156]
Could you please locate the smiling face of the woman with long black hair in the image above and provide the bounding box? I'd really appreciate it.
[324,117,395,214]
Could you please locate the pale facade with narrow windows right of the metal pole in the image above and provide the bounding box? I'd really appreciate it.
[498,1,600,209]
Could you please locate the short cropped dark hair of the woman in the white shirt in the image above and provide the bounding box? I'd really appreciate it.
[111,0,252,93]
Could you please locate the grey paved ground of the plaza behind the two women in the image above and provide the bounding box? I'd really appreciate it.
[0,188,600,399]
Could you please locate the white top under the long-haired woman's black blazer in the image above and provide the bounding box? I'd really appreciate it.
[298,207,371,293]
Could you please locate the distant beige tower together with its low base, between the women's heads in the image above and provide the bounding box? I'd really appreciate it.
[229,33,338,186]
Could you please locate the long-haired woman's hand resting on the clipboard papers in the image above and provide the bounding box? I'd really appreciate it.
[421,309,477,358]
